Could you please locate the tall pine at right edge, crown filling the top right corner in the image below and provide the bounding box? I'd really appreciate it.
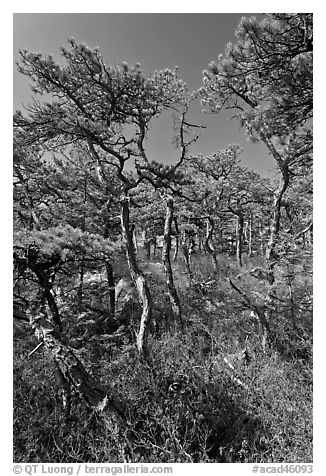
[201,13,313,274]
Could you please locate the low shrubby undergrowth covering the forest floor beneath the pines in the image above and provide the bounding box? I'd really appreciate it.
[14,251,312,463]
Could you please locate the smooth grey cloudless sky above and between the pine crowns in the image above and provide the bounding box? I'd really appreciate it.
[13,13,275,176]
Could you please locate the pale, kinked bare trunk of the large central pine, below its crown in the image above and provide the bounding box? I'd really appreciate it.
[121,197,152,358]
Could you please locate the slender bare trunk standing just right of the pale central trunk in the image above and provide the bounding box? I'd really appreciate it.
[162,198,181,323]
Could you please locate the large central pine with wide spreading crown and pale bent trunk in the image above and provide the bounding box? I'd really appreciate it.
[14,39,192,355]
